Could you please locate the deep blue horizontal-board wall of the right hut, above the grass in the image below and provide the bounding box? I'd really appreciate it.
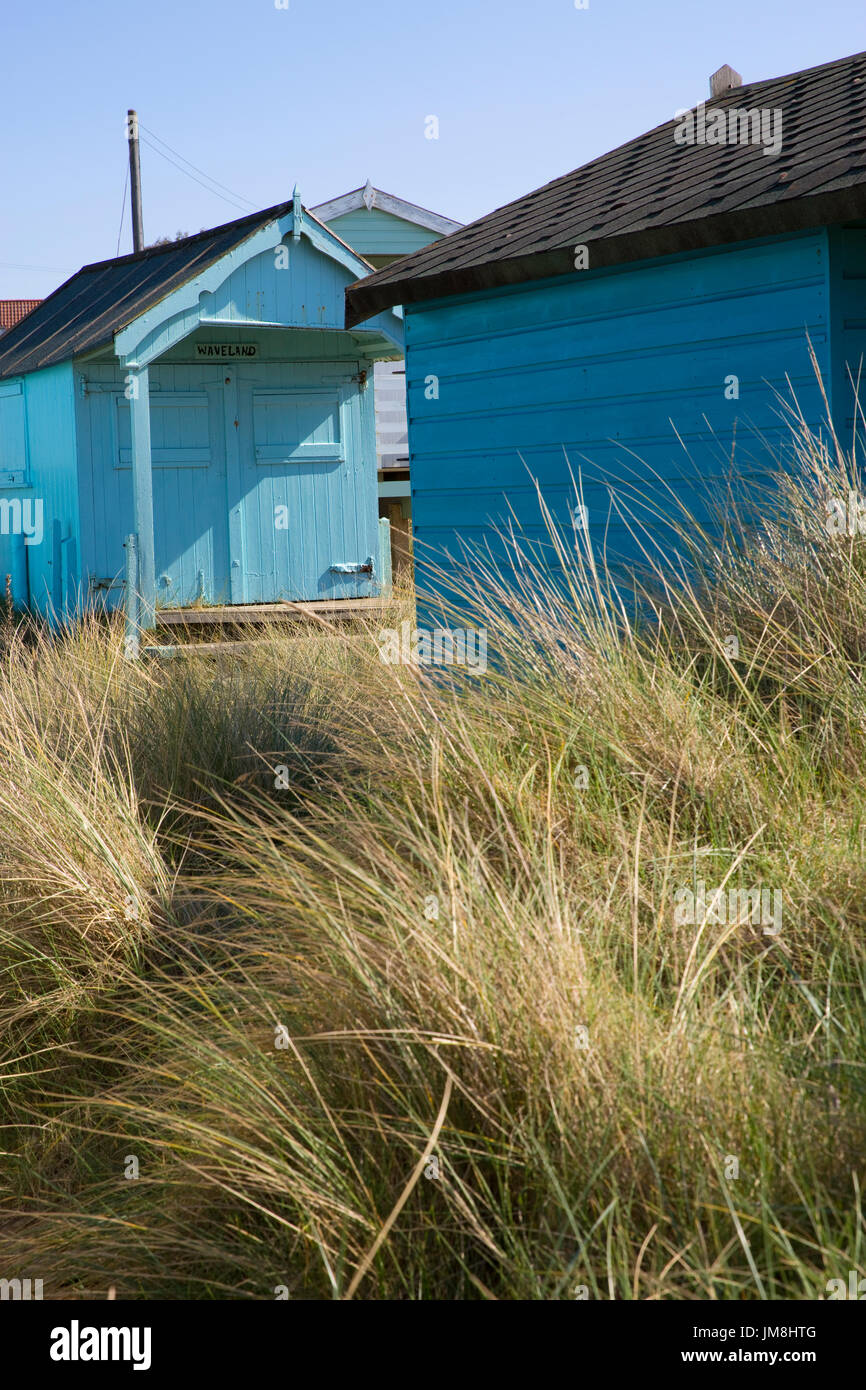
[406,229,830,592]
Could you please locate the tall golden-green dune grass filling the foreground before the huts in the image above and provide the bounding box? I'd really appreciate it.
[0,414,866,1300]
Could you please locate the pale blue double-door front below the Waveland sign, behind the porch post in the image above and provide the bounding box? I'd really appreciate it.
[86,360,377,609]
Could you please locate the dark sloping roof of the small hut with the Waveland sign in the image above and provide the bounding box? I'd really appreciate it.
[0,202,292,379]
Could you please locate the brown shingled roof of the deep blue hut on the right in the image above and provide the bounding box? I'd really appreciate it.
[346,53,866,328]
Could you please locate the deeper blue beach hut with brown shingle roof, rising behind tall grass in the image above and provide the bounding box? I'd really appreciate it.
[346,53,866,606]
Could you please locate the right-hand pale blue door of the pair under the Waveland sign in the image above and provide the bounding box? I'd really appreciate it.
[228,361,377,603]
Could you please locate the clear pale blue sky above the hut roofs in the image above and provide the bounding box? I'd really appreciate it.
[0,0,866,299]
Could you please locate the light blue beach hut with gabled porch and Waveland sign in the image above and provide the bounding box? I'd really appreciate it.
[0,196,403,626]
